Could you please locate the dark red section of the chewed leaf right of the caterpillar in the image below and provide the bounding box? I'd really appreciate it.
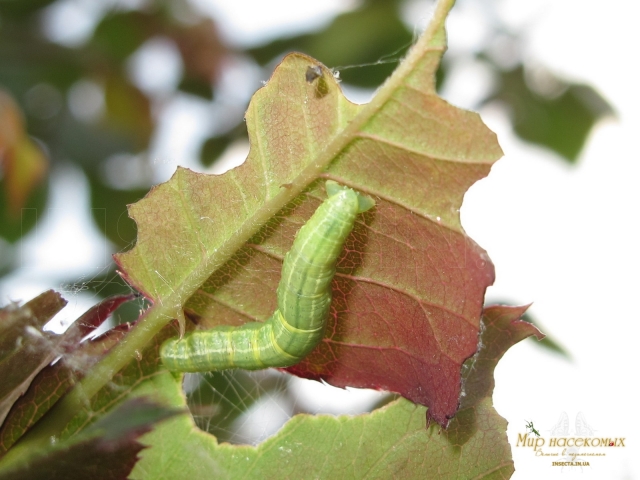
[288,197,494,426]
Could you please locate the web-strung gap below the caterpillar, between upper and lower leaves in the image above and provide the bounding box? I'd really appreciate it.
[183,369,394,445]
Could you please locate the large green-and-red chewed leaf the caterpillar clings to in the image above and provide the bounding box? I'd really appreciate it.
[116,0,502,425]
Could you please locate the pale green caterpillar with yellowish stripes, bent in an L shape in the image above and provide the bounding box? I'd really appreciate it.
[160,181,374,372]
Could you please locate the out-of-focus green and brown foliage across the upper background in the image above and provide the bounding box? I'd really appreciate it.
[0,0,611,293]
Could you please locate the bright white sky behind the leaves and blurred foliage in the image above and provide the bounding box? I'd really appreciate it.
[0,0,640,479]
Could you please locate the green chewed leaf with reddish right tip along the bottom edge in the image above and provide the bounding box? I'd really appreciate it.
[130,306,543,479]
